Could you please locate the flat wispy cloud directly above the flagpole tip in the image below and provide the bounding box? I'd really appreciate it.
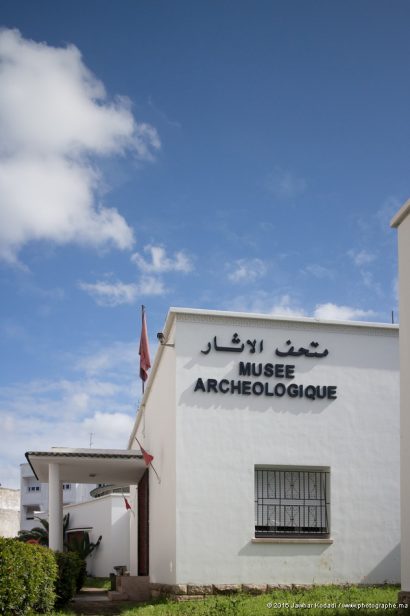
[78,276,166,308]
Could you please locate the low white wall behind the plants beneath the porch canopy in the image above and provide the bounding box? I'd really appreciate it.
[64,494,130,577]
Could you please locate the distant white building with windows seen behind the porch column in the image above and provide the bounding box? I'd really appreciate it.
[20,464,96,530]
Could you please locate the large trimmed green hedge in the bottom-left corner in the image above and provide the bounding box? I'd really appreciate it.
[0,537,57,616]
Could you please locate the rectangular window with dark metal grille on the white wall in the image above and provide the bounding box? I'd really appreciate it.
[255,467,330,537]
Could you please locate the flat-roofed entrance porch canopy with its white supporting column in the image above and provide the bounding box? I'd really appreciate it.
[26,447,146,551]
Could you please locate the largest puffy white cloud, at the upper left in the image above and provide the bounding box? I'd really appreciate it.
[0,30,160,262]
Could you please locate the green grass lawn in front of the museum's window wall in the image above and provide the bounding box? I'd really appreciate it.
[52,586,410,616]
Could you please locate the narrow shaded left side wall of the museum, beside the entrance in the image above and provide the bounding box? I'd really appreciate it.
[131,320,176,584]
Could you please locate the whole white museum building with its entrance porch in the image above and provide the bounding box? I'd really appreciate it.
[27,309,400,594]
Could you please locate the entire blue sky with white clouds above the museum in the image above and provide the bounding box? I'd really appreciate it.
[0,0,410,487]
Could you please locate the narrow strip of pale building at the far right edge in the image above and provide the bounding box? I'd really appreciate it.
[391,199,410,605]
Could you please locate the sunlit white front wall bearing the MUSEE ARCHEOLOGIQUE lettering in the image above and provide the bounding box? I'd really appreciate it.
[172,315,400,584]
